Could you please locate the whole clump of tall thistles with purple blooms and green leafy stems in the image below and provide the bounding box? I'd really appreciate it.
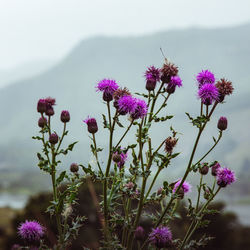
[15,59,236,249]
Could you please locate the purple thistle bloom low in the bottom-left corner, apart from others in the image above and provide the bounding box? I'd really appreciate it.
[18,220,45,244]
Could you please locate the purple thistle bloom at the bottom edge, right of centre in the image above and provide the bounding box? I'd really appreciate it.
[149,227,172,248]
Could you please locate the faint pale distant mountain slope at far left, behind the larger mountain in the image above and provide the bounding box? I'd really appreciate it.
[0,61,54,88]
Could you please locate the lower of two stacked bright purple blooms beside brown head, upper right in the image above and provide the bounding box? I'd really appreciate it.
[198,83,219,105]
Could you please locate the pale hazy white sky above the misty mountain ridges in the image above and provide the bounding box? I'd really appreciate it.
[0,0,250,69]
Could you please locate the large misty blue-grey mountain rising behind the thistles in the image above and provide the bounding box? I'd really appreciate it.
[0,24,250,189]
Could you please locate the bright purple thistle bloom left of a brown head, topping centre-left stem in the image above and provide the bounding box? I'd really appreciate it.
[96,79,119,102]
